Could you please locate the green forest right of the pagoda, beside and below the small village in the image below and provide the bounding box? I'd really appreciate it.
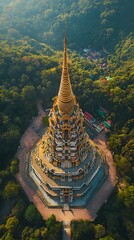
[71,37,134,240]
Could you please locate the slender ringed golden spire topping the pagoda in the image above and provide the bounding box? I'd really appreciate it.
[58,35,74,113]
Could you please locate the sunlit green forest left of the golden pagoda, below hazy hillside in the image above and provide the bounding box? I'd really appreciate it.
[0,38,62,240]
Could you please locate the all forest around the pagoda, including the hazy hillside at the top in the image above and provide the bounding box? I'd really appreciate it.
[0,0,134,240]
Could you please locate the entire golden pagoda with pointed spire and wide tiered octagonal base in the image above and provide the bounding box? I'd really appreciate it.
[29,37,108,207]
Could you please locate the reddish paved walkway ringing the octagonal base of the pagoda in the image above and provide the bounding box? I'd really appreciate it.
[16,105,116,240]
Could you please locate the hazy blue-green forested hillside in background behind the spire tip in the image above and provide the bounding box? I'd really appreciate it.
[0,0,134,49]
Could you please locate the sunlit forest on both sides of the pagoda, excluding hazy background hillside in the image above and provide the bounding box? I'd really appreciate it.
[0,36,134,240]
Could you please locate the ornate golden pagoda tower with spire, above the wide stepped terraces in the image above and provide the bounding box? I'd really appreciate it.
[43,38,89,168]
